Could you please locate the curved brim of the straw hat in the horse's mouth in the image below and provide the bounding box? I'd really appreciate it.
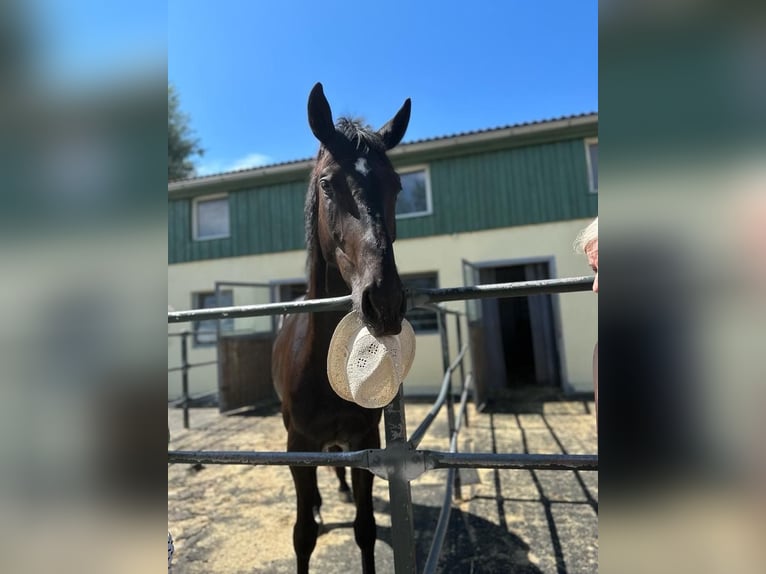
[327,311,415,403]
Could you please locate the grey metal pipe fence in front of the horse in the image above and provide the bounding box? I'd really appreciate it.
[168,277,598,574]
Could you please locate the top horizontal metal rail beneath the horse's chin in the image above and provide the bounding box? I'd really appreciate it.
[168,276,593,323]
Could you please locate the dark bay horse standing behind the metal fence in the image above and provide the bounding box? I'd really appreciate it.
[272,84,410,574]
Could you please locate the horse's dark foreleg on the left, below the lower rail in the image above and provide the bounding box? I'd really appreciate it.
[290,466,322,574]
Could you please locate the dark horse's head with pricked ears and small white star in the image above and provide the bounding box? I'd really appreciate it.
[308,83,410,336]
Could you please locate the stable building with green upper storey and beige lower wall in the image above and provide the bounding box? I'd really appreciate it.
[168,113,598,410]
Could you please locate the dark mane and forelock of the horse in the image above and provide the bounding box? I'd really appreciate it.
[303,117,390,276]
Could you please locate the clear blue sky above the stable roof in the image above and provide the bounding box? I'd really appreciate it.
[172,0,598,174]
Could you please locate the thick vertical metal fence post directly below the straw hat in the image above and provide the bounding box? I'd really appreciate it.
[383,386,417,574]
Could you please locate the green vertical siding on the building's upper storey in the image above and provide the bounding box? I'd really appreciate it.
[168,138,598,263]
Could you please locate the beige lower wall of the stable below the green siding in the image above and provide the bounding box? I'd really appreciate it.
[168,219,598,398]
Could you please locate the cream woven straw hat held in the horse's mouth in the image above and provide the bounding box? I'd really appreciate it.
[327,312,415,409]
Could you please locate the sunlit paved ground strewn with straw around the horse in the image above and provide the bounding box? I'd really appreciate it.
[168,398,598,574]
